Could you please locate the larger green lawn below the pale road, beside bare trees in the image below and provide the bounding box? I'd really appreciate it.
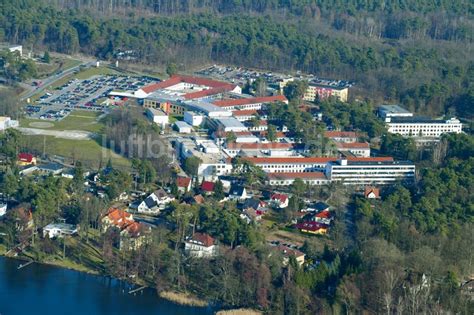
[21,136,130,169]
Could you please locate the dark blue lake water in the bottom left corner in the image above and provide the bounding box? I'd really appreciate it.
[0,257,214,315]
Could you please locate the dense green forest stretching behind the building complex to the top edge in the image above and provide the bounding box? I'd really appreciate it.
[0,0,474,118]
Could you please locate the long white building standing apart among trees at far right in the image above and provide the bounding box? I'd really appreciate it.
[385,118,462,138]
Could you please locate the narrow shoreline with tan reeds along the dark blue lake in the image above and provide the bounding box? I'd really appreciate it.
[0,251,209,308]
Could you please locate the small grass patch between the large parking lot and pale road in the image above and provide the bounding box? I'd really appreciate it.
[20,110,104,133]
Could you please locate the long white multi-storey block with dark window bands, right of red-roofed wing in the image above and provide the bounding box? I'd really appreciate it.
[325,158,415,185]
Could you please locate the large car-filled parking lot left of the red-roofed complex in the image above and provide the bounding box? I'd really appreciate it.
[26,75,158,120]
